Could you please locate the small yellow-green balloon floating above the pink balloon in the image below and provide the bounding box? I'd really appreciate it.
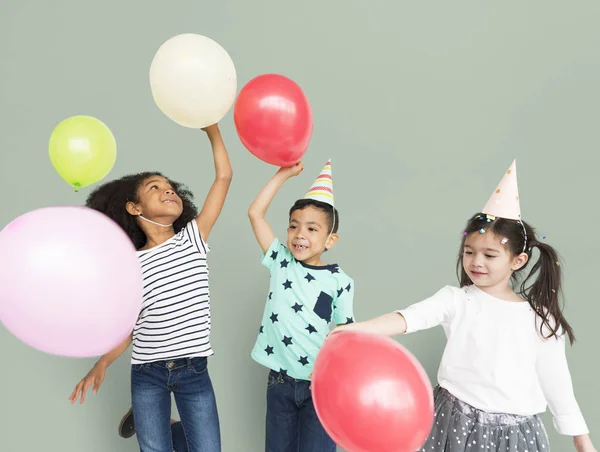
[49,116,117,191]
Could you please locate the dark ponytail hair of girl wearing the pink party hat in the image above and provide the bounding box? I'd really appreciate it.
[456,213,575,344]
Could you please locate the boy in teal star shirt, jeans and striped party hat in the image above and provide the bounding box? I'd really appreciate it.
[248,161,354,452]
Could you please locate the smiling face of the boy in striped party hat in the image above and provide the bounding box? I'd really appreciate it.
[287,206,338,266]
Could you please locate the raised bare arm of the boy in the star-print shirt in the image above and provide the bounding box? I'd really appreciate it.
[248,163,304,253]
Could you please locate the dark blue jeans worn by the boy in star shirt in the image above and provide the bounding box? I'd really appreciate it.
[265,370,336,452]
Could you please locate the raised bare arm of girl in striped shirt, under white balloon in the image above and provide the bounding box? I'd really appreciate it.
[196,124,233,241]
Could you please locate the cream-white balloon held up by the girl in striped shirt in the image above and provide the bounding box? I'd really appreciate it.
[150,33,237,128]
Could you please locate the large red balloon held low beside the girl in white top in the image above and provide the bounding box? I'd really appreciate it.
[312,331,433,452]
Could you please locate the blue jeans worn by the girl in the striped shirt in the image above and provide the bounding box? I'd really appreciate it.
[131,358,221,452]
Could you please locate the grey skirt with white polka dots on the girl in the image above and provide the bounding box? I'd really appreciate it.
[420,386,550,452]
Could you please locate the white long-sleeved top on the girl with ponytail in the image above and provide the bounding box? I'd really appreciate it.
[397,285,589,436]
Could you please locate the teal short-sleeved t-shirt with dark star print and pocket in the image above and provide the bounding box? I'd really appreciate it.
[252,238,354,380]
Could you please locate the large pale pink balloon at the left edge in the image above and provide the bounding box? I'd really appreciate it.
[0,206,142,357]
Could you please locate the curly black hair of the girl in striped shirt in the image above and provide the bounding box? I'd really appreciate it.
[85,172,198,249]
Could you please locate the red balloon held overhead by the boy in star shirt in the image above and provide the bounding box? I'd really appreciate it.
[233,74,313,167]
